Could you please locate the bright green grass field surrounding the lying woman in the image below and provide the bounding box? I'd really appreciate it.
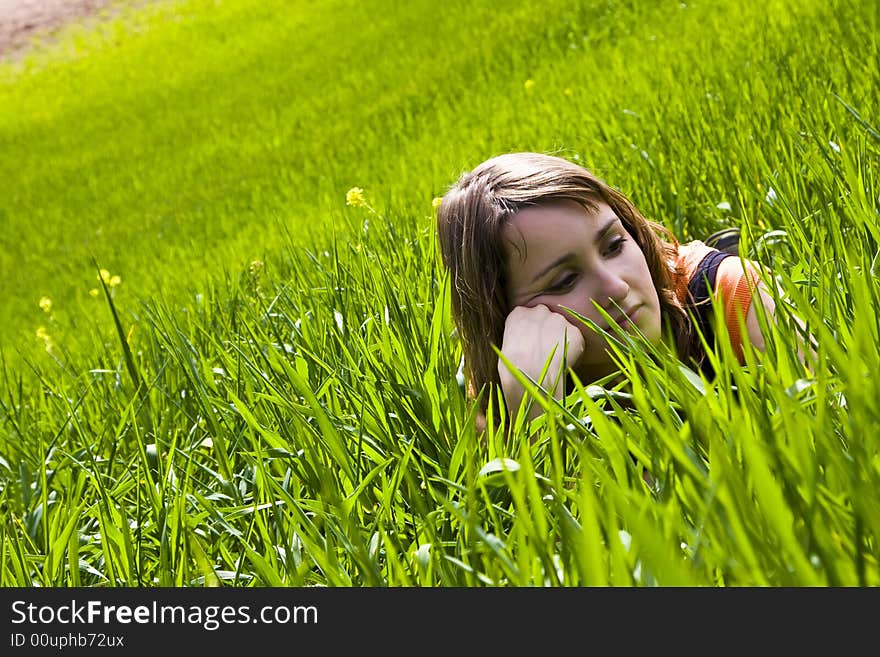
[0,0,880,586]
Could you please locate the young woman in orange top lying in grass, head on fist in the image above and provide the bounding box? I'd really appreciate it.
[437,153,774,416]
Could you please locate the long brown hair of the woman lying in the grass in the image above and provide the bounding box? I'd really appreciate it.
[437,153,693,409]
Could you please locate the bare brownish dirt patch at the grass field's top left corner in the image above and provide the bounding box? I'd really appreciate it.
[0,0,127,58]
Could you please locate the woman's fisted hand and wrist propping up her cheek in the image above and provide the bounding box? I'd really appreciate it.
[498,304,584,418]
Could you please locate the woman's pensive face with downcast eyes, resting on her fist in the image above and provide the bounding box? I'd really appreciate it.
[502,201,661,378]
